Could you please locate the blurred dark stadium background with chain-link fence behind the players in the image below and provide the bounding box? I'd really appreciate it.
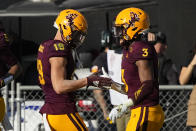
[0,0,196,131]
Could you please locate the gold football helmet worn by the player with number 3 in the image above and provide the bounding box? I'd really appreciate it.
[113,7,150,40]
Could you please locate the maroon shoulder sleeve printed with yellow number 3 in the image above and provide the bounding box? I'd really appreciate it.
[132,42,154,61]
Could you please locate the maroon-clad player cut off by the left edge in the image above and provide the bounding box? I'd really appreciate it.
[0,22,21,131]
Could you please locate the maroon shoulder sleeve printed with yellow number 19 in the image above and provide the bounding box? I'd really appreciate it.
[47,41,70,58]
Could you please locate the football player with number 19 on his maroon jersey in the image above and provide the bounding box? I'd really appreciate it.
[37,9,112,131]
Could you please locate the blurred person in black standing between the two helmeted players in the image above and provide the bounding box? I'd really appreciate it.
[91,31,126,131]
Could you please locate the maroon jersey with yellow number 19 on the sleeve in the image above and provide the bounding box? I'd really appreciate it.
[37,40,76,115]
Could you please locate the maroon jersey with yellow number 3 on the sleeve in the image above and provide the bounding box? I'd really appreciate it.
[122,41,159,108]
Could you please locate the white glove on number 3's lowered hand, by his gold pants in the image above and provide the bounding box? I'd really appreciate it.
[109,98,133,123]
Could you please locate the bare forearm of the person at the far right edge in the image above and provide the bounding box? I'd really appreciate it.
[179,64,194,85]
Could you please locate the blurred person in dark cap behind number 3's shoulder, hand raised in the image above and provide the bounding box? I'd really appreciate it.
[148,32,178,85]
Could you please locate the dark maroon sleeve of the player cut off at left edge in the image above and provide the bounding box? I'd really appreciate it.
[0,47,17,67]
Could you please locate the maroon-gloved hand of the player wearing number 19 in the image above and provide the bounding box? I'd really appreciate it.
[87,74,112,88]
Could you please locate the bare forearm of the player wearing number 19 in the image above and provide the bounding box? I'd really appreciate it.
[53,78,87,94]
